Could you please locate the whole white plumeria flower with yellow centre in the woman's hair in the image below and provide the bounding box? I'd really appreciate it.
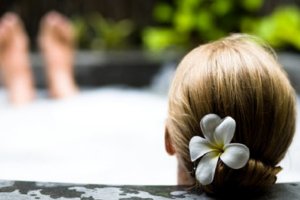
[189,114,250,185]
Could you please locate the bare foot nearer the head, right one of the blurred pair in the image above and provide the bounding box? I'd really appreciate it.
[39,12,78,98]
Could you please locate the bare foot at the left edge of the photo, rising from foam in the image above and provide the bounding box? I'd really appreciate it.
[0,13,35,105]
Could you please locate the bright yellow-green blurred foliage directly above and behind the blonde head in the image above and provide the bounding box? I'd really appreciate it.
[142,0,300,51]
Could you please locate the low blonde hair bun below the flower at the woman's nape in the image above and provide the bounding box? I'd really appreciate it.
[203,159,282,195]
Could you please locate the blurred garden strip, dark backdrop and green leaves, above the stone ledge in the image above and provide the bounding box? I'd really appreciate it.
[0,0,300,51]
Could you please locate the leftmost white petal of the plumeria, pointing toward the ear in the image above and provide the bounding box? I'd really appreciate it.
[189,136,213,162]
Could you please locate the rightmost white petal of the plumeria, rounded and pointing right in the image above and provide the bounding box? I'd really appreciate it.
[220,143,250,169]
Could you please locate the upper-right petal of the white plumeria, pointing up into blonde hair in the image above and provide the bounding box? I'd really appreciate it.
[214,117,236,146]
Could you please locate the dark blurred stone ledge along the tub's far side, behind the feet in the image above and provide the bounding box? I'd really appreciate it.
[31,50,300,93]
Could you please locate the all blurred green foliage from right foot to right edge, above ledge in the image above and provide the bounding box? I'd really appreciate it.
[72,0,300,51]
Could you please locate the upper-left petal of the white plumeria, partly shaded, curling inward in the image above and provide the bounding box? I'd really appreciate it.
[200,114,222,144]
